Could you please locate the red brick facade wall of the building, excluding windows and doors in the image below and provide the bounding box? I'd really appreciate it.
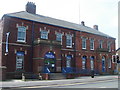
[2,17,115,77]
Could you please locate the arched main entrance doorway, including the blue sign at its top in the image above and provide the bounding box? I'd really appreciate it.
[44,52,55,72]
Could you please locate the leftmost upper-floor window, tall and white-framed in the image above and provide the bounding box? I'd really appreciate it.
[17,26,26,42]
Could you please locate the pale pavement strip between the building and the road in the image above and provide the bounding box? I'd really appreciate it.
[0,75,118,89]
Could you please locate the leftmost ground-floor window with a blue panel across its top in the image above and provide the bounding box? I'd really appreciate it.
[16,52,24,70]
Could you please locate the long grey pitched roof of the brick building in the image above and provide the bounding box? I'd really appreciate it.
[4,11,113,38]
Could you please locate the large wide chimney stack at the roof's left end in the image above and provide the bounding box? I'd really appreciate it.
[26,2,36,14]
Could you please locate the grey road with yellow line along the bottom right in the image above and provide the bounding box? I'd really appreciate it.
[2,78,118,90]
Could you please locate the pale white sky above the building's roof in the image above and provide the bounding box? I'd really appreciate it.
[0,0,120,49]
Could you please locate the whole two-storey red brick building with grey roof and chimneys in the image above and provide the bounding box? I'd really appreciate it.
[0,2,116,78]
